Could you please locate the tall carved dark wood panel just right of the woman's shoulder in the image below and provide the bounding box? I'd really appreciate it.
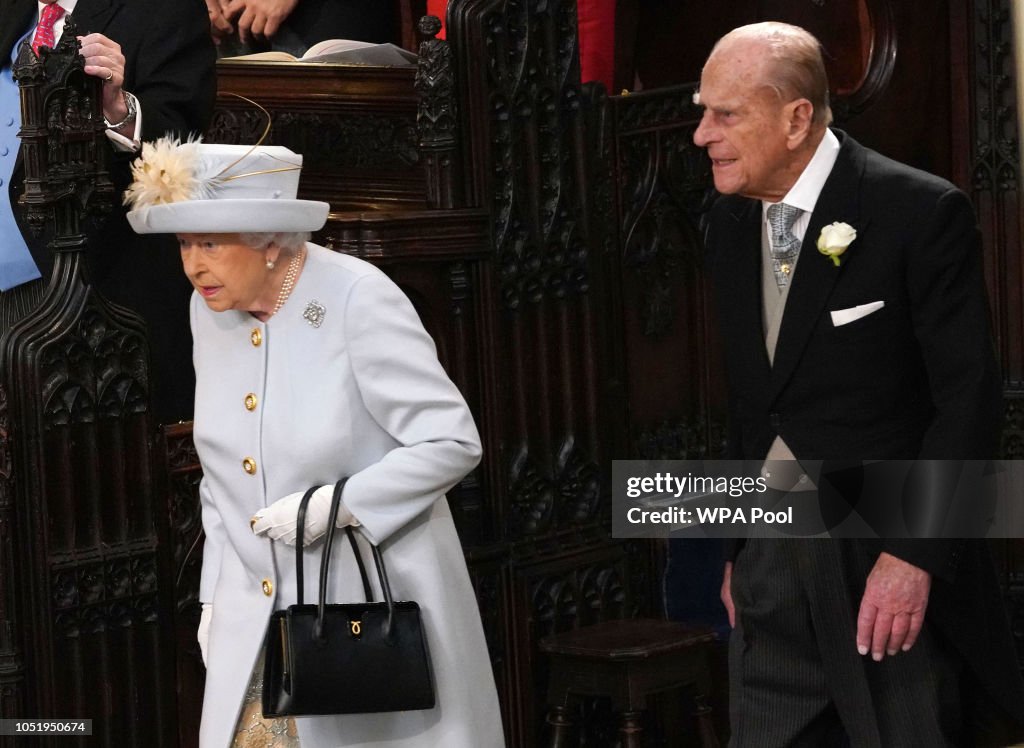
[449,0,601,538]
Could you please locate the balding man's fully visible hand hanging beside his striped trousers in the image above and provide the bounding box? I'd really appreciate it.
[857,552,932,662]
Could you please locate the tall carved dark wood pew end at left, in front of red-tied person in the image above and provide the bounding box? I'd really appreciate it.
[0,17,175,748]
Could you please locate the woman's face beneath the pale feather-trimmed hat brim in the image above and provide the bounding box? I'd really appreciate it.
[178,234,280,311]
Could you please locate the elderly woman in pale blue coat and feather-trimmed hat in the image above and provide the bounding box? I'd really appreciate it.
[125,140,504,748]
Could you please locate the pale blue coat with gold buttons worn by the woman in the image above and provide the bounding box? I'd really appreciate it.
[191,245,504,748]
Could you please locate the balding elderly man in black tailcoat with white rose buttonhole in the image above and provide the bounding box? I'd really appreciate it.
[694,23,1024,748]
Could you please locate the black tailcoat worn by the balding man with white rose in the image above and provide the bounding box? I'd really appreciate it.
[708,131,1024,720]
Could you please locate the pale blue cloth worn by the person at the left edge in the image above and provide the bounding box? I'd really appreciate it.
[0,29,41,291]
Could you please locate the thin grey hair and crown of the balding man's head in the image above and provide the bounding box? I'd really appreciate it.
[711,20,833,126]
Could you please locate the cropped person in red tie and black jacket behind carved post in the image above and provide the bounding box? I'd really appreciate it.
[0,0,216,422]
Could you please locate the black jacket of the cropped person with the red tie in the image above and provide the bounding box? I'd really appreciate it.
[0,0,216,422]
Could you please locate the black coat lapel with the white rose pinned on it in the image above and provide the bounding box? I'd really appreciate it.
[771,132,864,400]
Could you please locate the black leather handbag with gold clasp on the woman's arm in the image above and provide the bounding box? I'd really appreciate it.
[263,480,434,717]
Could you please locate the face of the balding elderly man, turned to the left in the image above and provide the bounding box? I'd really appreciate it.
[693,42,795,202]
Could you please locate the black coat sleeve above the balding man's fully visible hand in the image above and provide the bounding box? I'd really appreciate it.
[885,190,1002,581]
